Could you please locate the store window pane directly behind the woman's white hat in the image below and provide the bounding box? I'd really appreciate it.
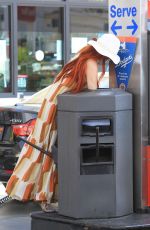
[70,8,109,88]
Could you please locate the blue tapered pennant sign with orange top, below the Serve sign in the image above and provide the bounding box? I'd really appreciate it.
[115,37,137,89]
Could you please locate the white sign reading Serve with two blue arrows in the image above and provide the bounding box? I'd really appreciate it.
[109,0,140,37]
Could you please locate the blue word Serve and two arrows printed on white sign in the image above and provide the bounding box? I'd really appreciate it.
[110,5,138,35]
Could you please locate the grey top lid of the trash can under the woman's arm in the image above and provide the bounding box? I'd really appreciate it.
[58,88,132,112]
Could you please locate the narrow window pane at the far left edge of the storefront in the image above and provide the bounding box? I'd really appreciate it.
[0,5,11,93]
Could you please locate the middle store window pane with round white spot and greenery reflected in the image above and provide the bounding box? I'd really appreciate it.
[18,6,63,92]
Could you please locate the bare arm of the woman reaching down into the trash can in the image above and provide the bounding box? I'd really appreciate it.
[86,59,98,90]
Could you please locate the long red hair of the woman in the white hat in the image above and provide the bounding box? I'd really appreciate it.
[54,45,107,93]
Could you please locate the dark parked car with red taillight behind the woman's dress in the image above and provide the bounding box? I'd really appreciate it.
[0,104,39,183]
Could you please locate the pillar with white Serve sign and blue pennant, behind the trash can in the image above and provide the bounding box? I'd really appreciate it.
[108,0,150,210]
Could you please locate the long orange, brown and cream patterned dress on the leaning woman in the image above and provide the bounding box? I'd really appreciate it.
[6,78,79,203]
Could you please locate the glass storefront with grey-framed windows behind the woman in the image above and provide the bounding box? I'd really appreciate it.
[0,0,108,99]
